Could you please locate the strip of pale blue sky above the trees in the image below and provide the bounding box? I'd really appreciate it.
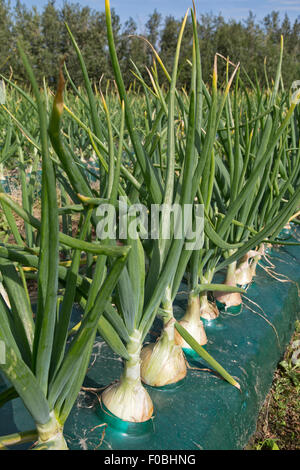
[12,0,300,28]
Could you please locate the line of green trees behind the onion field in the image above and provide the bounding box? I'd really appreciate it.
[0,0,300,88]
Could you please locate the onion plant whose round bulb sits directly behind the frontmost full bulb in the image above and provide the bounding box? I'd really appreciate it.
[106,1,241,394]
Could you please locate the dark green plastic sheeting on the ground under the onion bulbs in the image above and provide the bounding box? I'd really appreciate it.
[0,229,300,450]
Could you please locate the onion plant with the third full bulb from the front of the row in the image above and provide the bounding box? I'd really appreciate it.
[127,7,247,348]
